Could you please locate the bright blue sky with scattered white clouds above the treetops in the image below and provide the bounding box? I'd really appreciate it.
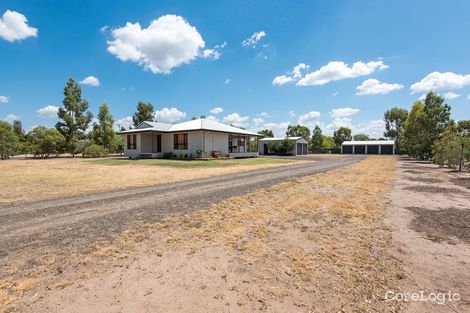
[0,0,470,137]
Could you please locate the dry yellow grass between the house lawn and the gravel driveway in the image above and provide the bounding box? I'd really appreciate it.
[0,158,304,204]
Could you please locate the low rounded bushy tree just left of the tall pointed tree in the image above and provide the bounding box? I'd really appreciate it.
[29,126,65,158]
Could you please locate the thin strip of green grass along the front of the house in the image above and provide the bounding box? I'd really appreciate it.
[87,158,294,168]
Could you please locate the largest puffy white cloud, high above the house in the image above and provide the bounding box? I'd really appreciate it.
[108,15,211,74]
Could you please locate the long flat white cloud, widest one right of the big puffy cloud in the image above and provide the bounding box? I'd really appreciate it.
[297,60,388,86]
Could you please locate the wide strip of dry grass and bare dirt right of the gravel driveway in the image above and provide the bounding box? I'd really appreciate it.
[0,157,402,313]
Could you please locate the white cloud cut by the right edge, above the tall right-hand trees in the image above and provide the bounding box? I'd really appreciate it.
[410,72,470,94]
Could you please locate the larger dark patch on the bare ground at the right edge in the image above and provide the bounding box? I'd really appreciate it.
[407,207,470,244]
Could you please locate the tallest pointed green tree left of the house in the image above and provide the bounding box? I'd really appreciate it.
[56,78,93,156]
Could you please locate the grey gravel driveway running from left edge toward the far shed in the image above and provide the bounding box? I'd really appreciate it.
[0,156,362,261]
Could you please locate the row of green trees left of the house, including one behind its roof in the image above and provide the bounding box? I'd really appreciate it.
[0,78,158,160]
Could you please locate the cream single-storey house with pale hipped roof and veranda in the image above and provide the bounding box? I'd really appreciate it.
[119,118,261,158]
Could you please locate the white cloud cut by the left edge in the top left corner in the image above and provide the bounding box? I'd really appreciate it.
[0,10,38,42]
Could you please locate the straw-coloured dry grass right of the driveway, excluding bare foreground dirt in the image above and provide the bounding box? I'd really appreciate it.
[1,156,401,312]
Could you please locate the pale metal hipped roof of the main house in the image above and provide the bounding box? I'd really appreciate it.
[119,118,261,136]
